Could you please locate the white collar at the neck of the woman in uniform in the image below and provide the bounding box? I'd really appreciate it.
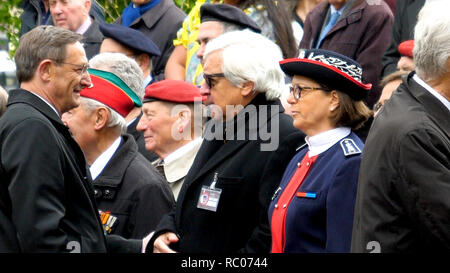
[305,127,351,157]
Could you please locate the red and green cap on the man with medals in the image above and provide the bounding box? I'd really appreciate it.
[80,68,142,117]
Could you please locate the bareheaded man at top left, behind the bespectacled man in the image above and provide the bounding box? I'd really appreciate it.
[49,0,103,60]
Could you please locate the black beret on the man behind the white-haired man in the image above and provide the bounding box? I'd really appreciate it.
[200,4,261,33]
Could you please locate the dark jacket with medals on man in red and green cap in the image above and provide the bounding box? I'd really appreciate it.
[94,134,175,239]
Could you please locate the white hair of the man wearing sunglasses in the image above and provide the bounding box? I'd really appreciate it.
[204,30,284,100]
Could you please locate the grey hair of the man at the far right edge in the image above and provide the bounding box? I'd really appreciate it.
[413,0,450,81]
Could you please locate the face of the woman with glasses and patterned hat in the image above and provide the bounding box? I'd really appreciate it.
[287,75,337,136]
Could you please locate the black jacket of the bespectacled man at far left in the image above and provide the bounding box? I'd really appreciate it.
[0,89,142,252]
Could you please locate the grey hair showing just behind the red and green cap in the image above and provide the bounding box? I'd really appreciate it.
[89,52,145,101]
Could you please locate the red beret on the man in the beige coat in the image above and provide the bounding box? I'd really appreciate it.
[142,80,206,103]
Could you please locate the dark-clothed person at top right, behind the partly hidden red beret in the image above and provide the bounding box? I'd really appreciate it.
[381,0,426,77]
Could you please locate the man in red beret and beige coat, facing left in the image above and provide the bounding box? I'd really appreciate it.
[137,80,204,200]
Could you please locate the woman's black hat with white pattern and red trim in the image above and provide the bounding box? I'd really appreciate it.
[280,49,372,100]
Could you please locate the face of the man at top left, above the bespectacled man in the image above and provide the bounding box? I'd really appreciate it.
[49,0,91,31]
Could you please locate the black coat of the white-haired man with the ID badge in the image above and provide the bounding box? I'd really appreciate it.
[147,94,304,253]
